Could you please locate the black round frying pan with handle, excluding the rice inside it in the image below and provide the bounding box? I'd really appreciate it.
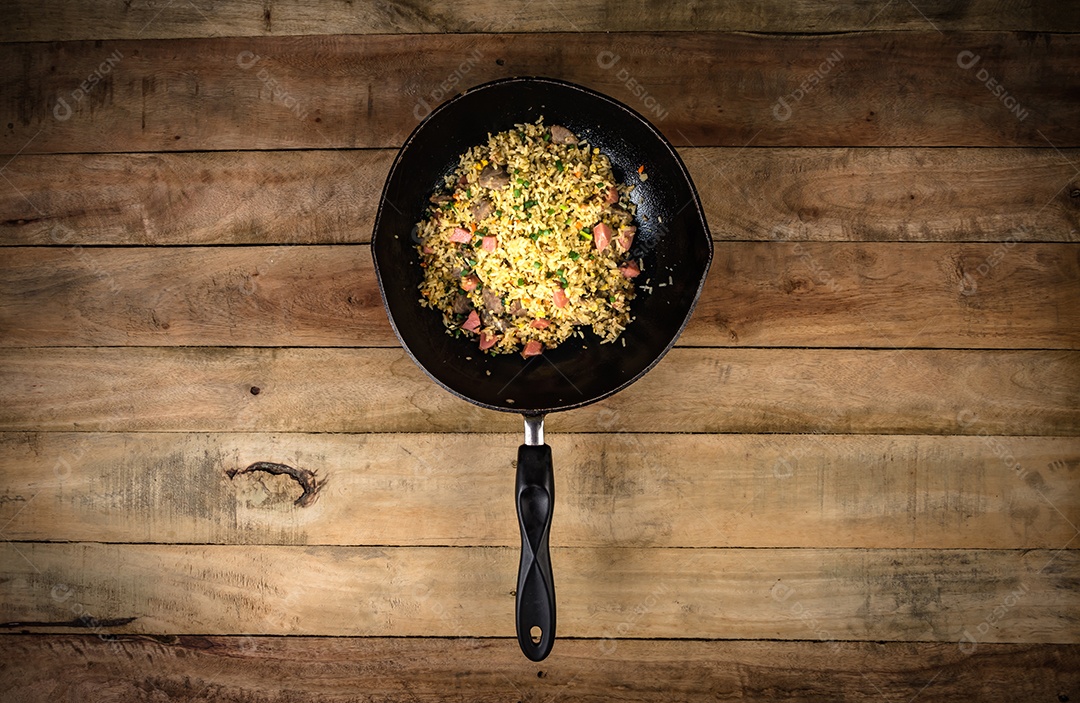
[372,78,713,661]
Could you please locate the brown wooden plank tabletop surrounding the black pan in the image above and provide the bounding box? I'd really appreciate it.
[0,0,1080,701]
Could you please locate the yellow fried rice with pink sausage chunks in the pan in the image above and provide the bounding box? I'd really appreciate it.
[416,118,640,356]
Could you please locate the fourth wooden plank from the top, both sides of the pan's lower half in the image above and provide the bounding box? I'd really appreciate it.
[0,242,1080,349]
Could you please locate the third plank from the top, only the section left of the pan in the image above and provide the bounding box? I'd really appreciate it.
[0,150,388,246]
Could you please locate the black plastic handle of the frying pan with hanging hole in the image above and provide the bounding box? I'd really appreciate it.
[516,444,555,662]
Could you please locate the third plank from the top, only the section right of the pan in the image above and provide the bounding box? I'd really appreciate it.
[681,148,1080,242]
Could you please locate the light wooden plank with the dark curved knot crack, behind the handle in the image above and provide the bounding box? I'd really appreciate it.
[0,433,1080,549]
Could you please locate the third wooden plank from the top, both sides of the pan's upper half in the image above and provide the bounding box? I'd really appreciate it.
[0,147,1080,246]
